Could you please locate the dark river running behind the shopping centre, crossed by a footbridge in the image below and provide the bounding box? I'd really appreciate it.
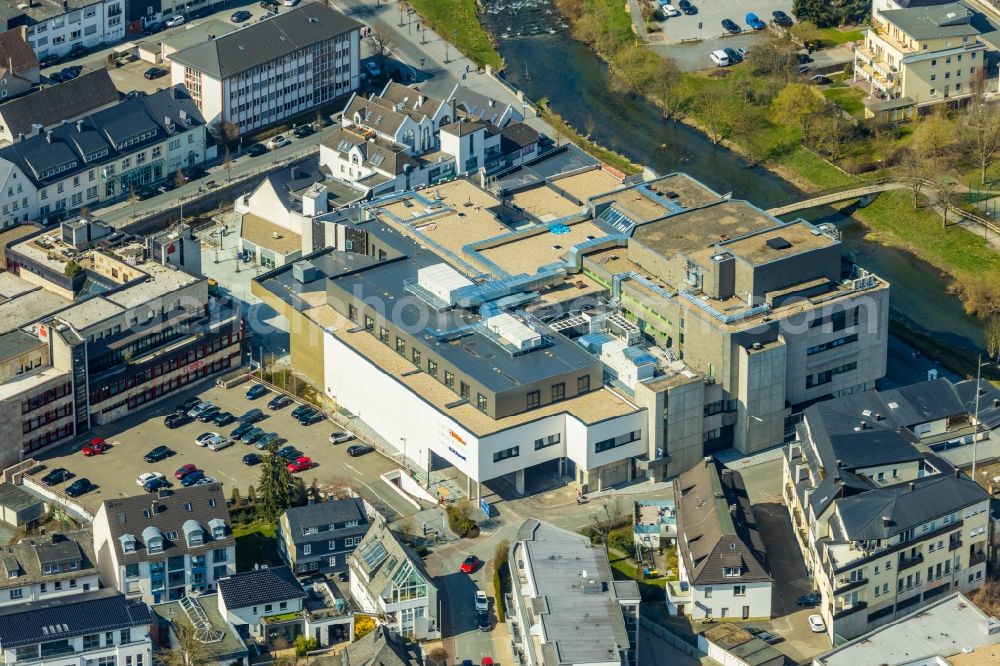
[481,0,983,350]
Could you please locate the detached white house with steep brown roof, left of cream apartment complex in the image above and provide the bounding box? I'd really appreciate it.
[667,457,774,620]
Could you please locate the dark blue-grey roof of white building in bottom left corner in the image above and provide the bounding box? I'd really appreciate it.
[0,588,152,650]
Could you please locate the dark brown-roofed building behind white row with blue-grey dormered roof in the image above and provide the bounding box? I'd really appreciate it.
[0,67,121,143]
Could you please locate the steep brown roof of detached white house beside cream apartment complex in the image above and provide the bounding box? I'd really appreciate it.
[674,459,771,585]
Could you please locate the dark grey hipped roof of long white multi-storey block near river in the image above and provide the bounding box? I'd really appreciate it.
[168,3,362,80]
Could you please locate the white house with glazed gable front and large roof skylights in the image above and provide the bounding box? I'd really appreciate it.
[348,519,441,640]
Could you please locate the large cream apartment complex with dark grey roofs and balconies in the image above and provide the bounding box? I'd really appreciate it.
[783,379,990,640]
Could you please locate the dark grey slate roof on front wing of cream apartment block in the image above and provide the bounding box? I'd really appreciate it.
[837,466,990,541]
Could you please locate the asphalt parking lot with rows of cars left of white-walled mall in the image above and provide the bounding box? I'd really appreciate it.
[25,382,415,517]
